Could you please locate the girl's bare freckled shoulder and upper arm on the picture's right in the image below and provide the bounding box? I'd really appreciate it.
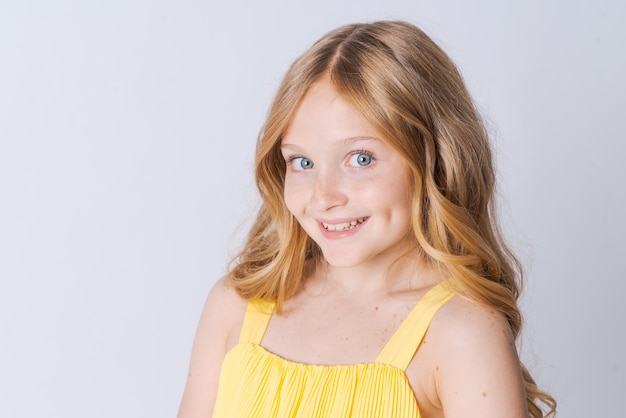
[420,296,528,418]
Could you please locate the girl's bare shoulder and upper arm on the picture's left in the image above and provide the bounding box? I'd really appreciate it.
[178,279,246,418]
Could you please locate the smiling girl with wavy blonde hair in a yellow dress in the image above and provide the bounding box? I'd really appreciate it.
[178,22,555,418]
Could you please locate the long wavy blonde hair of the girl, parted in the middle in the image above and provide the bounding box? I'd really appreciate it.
[229,21,556,418]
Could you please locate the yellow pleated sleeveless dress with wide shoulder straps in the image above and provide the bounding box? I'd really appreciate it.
[213,283,453,418]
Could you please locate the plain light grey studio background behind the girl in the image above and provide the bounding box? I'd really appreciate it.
[0,0,626,418]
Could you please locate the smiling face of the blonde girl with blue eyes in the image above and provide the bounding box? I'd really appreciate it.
[281,80,411,267]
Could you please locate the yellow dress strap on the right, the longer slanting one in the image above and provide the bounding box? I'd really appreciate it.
[376,282,454,370]
